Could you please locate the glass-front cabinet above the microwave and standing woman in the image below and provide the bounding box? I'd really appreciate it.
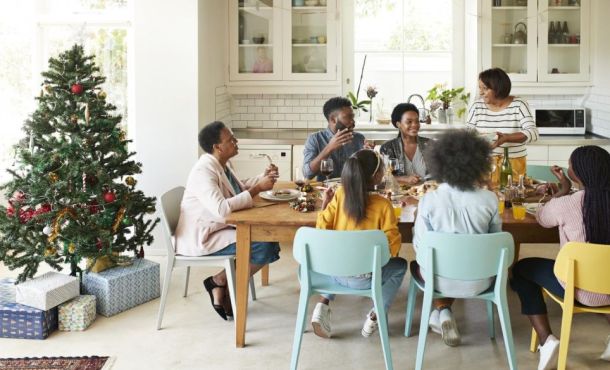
[482,0,589,82]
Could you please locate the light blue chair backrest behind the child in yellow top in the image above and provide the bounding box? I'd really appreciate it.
[293,227,390,276]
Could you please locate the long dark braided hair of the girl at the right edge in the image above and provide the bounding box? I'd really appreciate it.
[570,145,610,244]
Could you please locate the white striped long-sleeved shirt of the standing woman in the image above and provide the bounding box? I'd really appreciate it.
[466,97,538,158]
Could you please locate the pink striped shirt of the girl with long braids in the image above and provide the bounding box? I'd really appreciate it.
[536,191,610,307]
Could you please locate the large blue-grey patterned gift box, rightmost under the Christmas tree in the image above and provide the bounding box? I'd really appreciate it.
[83,258,160,316]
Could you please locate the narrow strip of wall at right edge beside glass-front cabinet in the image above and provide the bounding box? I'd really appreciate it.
[585,0,610,137]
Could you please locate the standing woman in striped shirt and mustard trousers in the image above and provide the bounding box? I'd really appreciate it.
[466,68,538,184]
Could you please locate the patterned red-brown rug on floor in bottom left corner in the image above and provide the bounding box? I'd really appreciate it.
[0,356,113,370]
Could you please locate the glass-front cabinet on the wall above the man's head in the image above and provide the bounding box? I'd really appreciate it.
[229,0,340,81]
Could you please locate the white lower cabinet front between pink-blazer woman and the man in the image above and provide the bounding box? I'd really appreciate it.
[231,144,293,181]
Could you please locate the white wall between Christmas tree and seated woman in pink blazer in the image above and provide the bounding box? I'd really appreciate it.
[134,0,199,253]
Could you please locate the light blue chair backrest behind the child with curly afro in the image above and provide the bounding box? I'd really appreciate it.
[417,231,515,280]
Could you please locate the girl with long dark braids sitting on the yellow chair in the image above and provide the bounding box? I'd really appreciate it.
[511,146,610,370]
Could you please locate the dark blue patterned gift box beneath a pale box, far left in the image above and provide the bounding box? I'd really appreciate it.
[0,303,57,339]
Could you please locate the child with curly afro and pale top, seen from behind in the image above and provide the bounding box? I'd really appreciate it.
[411,130,502,346]
